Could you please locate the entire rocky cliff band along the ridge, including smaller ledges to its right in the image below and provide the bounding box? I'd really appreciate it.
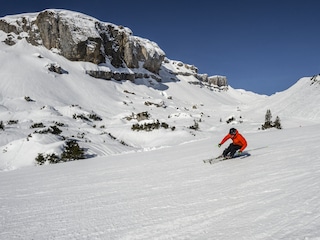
[0,9,227,87]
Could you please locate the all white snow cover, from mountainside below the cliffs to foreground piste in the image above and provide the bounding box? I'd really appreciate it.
[0,8,320,240]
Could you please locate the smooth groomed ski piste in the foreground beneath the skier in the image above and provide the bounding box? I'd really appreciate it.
[0,127,320,240]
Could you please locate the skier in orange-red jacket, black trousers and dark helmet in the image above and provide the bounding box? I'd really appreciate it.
[218,128,247,158]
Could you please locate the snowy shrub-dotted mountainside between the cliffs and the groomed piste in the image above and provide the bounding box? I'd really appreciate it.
[0,9,320,169]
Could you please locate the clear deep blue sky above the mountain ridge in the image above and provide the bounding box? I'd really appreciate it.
[0,0,320,95]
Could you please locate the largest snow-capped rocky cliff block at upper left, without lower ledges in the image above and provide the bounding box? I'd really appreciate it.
[0,10,165,74]
